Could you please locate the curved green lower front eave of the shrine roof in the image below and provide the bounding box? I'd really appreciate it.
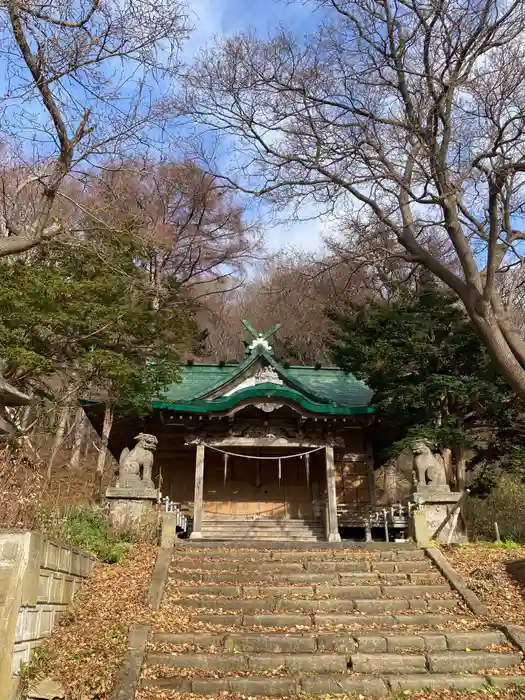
[152,384,374,416]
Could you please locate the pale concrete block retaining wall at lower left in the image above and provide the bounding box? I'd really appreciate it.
[0,532,95,700]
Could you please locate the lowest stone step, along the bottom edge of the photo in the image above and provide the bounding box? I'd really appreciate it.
[141,673,525,697]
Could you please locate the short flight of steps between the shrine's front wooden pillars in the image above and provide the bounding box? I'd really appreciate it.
[201,518,326,542]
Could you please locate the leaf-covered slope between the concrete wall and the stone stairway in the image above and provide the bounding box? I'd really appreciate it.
[25,544,157,700]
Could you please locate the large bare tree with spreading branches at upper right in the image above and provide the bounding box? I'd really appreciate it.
[184,0,525,397]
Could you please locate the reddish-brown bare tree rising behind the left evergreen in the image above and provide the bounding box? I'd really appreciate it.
[86,158,260,302]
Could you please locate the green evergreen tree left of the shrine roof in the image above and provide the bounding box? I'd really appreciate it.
[0,232,193,411]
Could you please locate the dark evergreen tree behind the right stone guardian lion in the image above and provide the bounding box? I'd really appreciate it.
[332,280,519,487]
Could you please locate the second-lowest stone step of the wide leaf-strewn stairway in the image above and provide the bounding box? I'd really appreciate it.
[146,651,522,675]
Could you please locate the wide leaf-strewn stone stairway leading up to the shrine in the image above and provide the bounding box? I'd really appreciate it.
[138,543,525,697]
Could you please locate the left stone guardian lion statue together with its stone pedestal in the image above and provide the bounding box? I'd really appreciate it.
[106,433,158,531]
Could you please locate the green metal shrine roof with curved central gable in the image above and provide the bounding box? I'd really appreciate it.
[152,347,373,415]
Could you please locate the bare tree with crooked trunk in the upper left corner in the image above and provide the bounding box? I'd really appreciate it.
[0,0,188,256]
